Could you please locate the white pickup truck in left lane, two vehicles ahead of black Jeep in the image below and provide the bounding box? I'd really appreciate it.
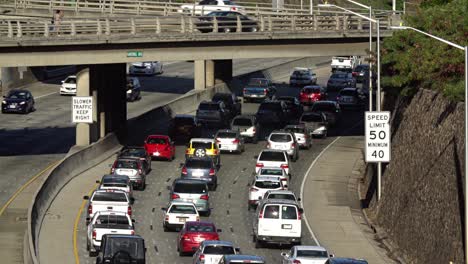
[83,190,133,224]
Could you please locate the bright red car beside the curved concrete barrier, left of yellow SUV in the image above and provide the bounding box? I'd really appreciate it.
[145,135,175,160]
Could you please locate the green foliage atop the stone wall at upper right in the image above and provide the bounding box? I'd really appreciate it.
[382,0,468,100]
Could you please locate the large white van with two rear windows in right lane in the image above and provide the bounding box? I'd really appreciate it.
[253,199,303,248]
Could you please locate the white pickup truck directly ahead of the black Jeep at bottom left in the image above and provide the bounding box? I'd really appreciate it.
[86,212,135,257]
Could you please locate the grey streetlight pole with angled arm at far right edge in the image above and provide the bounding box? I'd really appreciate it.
[391,26,468,263]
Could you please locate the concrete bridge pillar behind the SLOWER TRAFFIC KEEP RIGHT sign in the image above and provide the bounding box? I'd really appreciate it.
[76,63,127,146]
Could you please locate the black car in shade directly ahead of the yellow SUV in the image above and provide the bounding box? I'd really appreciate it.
[169,115,200,140]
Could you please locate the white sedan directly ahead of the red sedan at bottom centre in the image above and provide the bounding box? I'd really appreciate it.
[161,202,200,232]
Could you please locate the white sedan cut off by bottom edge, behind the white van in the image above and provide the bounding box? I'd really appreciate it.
[281,246,333,264]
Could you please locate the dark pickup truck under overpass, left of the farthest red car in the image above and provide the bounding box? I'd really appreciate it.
[242,78,276,103]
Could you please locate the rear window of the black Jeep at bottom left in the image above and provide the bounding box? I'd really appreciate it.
[103,237,145,259]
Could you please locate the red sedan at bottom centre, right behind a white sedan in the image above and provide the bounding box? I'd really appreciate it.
[177,221,221,256]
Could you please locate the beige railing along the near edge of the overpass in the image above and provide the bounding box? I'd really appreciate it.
[0,12,392,39]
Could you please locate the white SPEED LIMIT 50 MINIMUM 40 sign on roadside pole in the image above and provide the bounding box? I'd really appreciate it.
[365,111,390,162]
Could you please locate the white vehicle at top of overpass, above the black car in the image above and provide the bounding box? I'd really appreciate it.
[177,0,245,16]
